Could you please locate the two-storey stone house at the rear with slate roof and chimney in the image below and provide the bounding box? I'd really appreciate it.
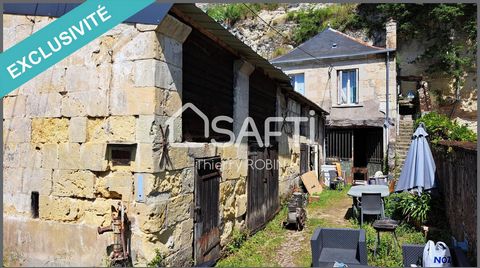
[271,21,398,179]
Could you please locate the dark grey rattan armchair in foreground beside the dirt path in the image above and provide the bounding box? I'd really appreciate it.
[310,228,367,267]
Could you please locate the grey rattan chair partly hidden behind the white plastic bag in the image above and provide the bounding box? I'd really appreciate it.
[402,244,471,267]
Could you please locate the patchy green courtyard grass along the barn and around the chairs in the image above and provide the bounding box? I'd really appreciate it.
[217,186,448,267]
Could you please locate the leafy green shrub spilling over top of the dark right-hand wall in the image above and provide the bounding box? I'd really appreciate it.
[415,112,477,143]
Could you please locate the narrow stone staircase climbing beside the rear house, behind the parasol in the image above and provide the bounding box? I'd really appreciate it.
[395,117,414,178]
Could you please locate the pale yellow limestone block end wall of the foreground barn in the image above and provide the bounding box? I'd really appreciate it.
[3,14,193,265]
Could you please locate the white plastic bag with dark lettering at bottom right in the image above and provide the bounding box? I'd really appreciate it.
[423,240,452,267]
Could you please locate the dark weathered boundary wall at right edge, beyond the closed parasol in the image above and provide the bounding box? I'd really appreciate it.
[432,143,478,266]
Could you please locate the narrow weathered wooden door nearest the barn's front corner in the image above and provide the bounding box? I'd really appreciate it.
[194,157,221,265]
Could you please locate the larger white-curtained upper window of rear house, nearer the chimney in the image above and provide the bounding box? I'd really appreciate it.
[338,69,358,105]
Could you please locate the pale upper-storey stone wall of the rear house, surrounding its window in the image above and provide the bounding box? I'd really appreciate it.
[282,56,397,126]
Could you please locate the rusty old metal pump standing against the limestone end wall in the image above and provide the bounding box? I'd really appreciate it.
[97,202,130,266]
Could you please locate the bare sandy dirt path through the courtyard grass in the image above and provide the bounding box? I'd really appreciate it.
[276,194,352,267]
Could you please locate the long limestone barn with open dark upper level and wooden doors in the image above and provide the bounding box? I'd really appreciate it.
[3,4,326,266]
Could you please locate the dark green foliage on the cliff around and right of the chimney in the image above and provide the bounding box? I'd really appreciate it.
[355,4,477,92]
